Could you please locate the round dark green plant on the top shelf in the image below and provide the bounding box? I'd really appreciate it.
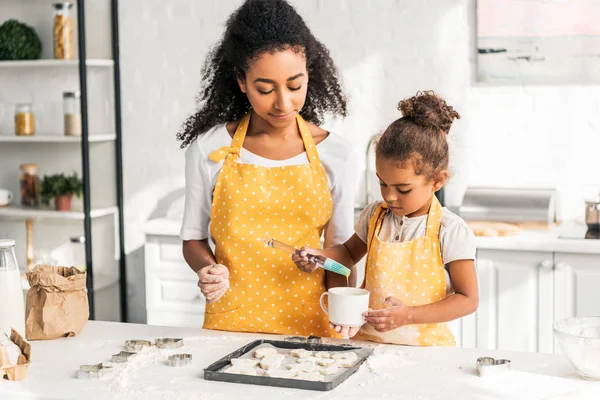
[0,19,42,60]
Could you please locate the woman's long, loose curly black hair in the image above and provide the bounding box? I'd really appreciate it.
[177,0,347,148]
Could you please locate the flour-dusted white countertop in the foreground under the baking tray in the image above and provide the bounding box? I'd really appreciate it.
[0,321,600,400]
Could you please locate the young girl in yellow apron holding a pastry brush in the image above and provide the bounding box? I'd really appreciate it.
[294,92,479,346]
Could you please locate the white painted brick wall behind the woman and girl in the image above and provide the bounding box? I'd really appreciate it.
[120,0,600,320]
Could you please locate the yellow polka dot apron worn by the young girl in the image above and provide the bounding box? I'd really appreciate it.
[356,196,455,346]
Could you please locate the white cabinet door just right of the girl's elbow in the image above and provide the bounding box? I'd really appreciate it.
[475,250,554,352]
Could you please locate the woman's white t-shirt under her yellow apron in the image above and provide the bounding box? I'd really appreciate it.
[180,124,357,247]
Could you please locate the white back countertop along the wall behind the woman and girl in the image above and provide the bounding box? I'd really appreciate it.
[144,219,600,254]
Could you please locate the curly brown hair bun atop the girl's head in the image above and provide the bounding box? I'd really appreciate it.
[398,90,460,134]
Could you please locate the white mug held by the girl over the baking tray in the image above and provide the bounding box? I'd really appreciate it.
[321,287,369,327]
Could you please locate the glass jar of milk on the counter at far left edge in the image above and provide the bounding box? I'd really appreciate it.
[0,239,25,335]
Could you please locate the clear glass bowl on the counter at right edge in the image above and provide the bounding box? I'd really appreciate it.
[554,317,600,380]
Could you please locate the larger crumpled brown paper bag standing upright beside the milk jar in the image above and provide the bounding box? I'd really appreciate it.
[25,265,90,340]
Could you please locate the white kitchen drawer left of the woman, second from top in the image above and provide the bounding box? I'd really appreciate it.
[146,271,205,314]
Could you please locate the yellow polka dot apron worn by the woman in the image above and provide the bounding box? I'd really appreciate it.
[204,112,334,337]
